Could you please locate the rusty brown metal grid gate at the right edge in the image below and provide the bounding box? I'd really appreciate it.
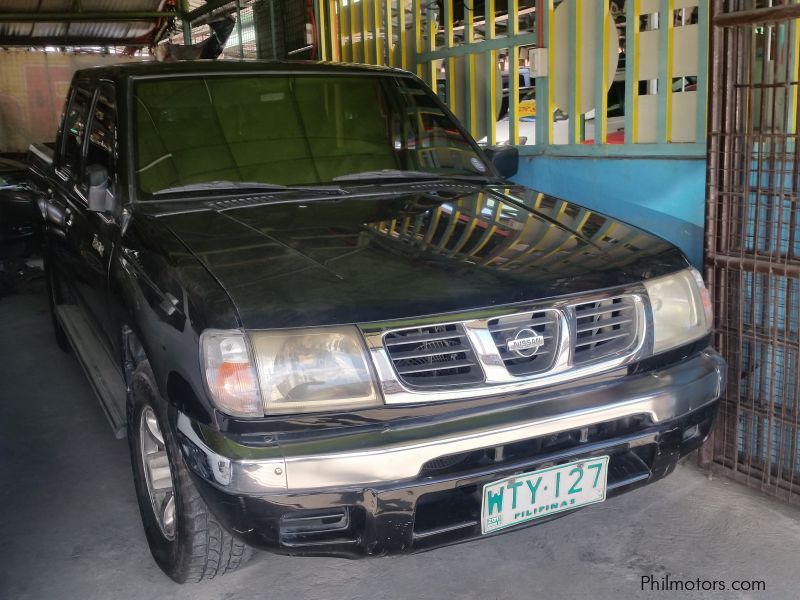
[705,0,800,504]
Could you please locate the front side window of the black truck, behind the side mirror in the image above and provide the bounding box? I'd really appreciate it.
[81,83,117,194]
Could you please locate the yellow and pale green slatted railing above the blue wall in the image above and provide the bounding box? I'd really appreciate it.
[315,0,708,156]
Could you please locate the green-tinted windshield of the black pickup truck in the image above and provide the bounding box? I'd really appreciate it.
[134,74,489,197]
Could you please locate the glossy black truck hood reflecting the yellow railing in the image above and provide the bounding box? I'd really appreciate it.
[152,182,688,329]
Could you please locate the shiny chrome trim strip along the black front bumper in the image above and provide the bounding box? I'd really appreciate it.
[177,350,725,495]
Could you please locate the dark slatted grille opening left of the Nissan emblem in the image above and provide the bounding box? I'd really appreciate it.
[383,324,483,388]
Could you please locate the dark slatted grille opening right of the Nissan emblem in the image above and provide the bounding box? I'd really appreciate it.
[572,296,638,365]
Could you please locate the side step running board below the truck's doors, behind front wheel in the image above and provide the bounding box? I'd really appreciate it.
[56,304,126,439]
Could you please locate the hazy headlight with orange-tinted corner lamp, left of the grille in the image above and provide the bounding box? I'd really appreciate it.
[201,327,381,417]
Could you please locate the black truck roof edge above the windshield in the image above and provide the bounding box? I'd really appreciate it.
[75,60,406,82]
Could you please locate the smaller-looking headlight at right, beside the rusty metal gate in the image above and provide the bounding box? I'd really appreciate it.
[644,269,713,354]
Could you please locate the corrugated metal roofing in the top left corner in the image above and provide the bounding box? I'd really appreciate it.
[0,0,174,46]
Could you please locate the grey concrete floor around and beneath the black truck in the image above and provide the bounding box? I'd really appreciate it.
[0,286,800,600]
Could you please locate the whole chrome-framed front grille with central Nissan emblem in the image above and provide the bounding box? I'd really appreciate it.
[376,286,652,396]
